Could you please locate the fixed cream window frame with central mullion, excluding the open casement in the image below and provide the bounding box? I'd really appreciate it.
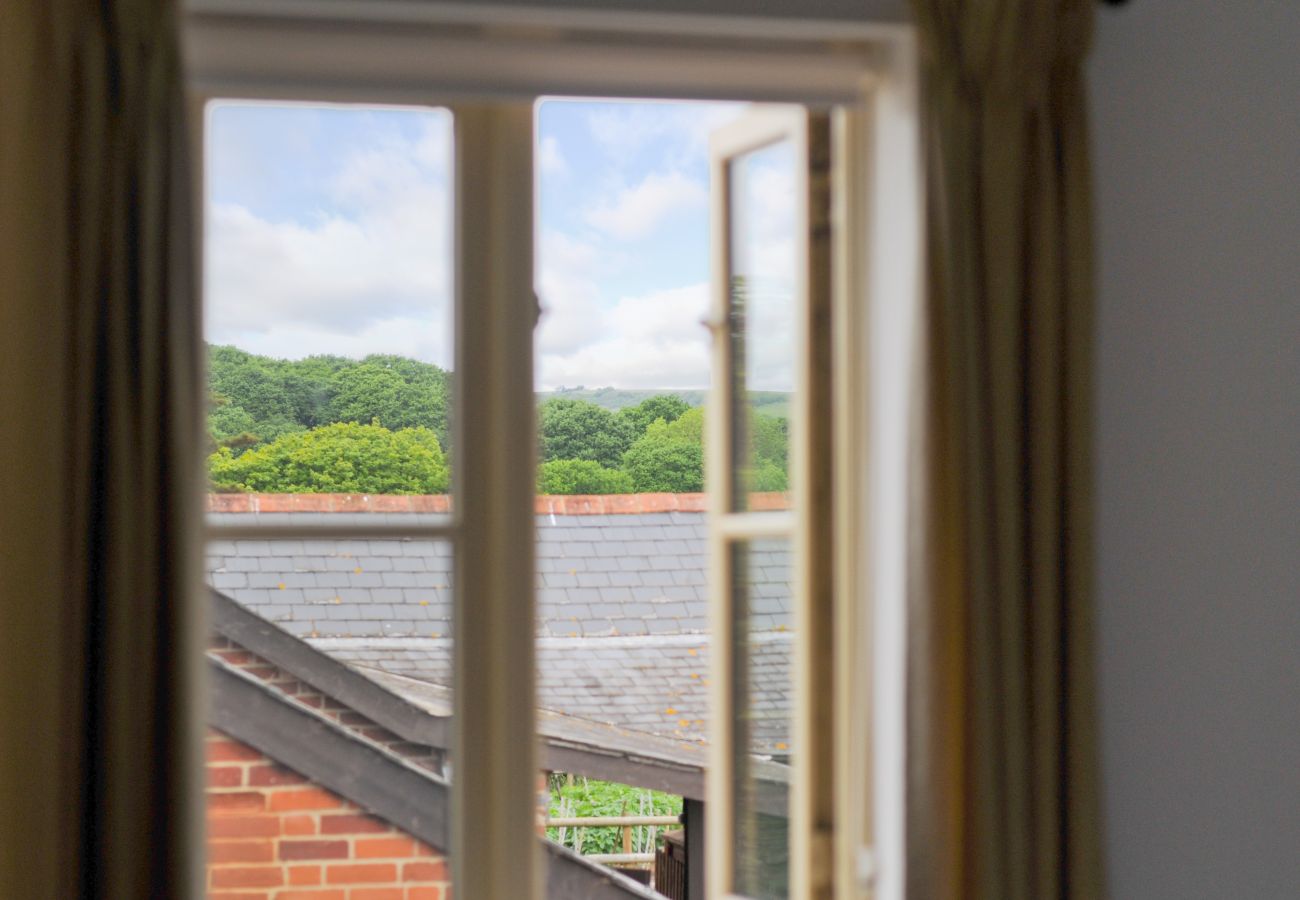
[183,0,922,900]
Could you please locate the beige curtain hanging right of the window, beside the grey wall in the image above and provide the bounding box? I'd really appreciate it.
[907,0,1102,900]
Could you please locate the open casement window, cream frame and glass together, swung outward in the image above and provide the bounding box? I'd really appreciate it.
[707,107,836,900]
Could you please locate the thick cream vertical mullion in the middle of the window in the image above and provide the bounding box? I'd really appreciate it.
[451,104,541,900]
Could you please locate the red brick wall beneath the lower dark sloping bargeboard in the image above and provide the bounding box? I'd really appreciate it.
[207,730,451,900]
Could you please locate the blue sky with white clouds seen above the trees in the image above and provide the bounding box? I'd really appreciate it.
[205,100,793,390]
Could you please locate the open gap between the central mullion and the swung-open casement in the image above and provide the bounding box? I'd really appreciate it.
[536,98,745,896]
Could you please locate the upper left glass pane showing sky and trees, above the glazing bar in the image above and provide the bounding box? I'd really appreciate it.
[204,101,452,509]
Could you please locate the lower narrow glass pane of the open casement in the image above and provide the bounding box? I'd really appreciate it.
[731,540,794,900]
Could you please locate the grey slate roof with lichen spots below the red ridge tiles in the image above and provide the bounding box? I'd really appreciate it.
[208,511,793,756]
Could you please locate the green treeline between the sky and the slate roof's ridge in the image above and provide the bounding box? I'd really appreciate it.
[208,346,788,494]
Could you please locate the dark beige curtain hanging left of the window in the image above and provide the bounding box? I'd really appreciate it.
[0,0,202,900]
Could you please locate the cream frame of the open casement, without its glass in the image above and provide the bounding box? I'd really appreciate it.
[706,105,836,900]
